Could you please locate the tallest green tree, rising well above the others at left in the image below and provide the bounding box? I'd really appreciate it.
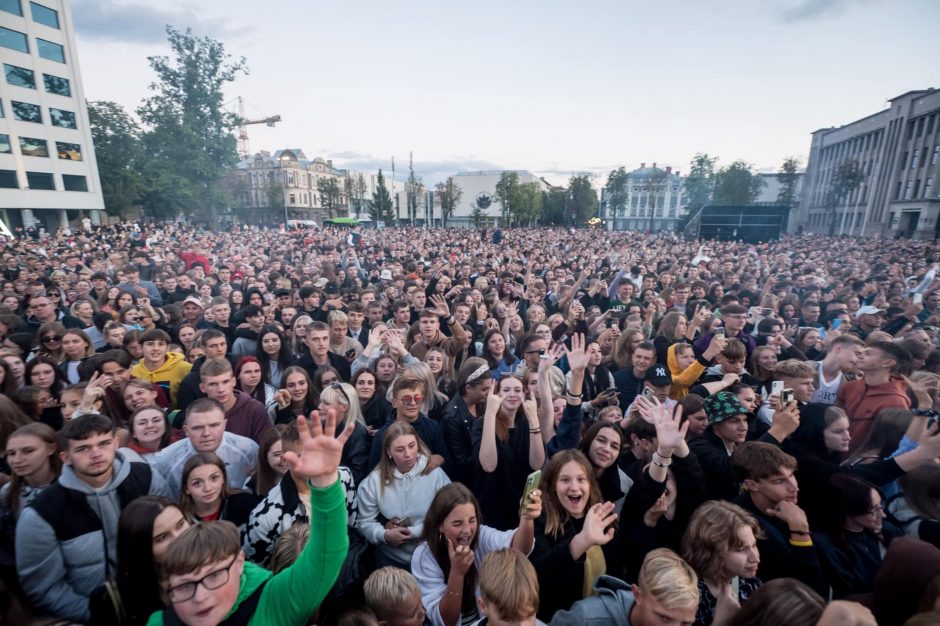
[137,26,247,227]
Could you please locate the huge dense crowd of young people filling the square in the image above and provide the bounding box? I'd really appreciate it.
[0,223,940,626]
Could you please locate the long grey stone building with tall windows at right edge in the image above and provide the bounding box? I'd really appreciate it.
[798,89,940,239]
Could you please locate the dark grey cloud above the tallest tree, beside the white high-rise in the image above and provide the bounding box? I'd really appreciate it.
[72,0,249,44]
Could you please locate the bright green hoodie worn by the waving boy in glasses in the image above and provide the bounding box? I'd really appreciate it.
[147,480,349,626]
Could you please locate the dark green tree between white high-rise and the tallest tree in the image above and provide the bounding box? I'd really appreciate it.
[88,101,144,215]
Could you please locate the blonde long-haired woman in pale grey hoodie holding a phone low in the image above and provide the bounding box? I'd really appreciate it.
[356,422,450,568]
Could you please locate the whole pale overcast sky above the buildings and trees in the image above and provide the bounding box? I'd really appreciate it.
[72,0,940,184]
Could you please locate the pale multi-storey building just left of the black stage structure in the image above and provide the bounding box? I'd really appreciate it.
[598,163,688,231]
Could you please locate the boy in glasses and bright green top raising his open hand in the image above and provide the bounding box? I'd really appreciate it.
[154,411,353,626]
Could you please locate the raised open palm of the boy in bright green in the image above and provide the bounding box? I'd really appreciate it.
[284,409,355,487]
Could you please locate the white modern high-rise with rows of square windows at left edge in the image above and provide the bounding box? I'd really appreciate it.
[0,0,104,233]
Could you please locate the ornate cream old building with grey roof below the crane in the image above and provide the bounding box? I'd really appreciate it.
[236,148,388,223]
